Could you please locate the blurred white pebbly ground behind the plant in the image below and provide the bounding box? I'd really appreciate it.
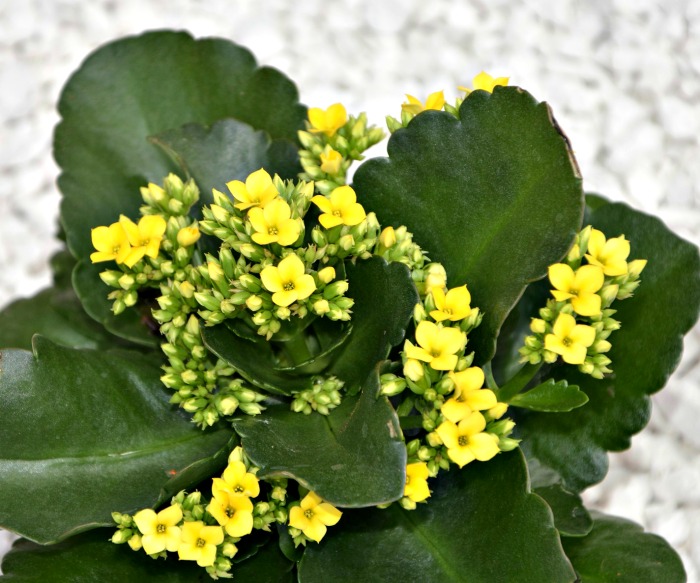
[0,0,700,583]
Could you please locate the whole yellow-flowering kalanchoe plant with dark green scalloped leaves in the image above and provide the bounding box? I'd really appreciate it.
[0,32,700,583]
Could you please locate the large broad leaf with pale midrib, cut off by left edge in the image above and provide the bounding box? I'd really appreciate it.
[0,336,234,544]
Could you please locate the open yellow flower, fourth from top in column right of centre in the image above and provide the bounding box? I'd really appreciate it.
[435,411,499,468]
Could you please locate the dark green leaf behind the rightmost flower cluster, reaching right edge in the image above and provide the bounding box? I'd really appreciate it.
[516,203,700,491]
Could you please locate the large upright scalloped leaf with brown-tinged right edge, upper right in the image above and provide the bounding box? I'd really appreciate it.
[354,87,583,363]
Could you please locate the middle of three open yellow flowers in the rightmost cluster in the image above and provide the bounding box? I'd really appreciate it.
[549,263,605,316]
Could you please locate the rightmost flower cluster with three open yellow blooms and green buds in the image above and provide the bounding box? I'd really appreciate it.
[520,226,646,379]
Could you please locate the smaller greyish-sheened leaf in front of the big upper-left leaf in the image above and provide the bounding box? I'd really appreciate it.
[151,119,302,211]
